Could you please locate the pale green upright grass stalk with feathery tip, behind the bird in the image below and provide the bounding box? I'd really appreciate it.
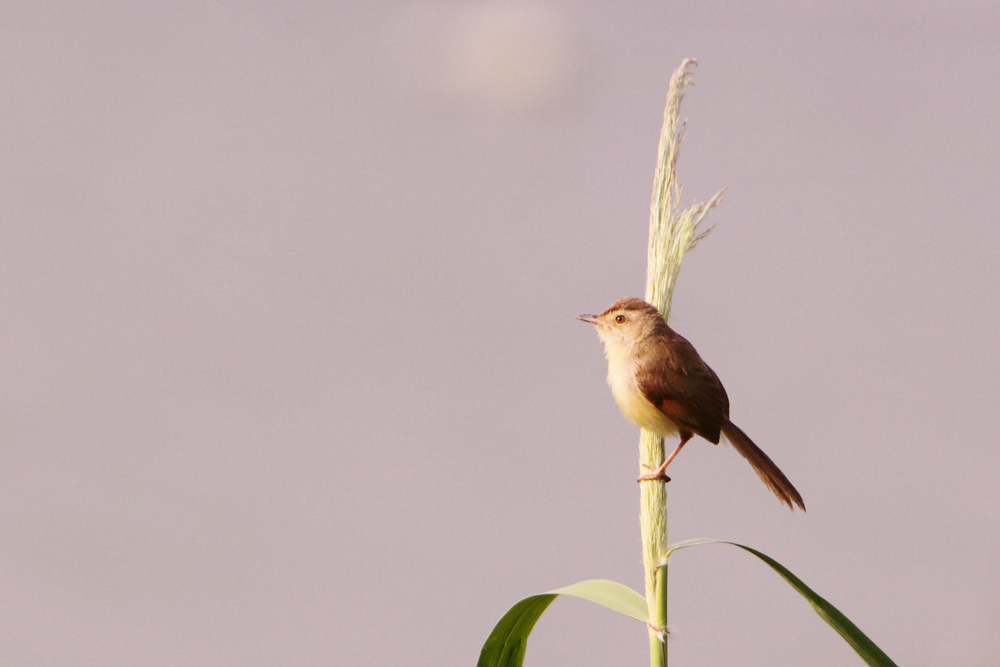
[639,58,723,667]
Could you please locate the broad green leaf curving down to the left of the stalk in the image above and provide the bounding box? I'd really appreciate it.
[476,579,647,667]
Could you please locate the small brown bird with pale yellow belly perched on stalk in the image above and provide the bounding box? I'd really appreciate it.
[577,297,806,511]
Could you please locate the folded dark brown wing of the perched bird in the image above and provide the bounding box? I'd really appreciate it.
[636,330,729,444]
